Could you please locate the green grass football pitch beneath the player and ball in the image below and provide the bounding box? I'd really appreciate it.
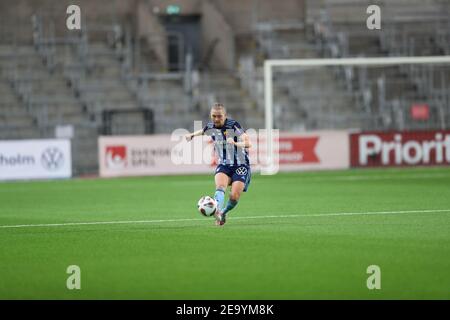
[0,168,450,299]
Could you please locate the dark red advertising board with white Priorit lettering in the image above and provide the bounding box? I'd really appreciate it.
[350,130,450,167]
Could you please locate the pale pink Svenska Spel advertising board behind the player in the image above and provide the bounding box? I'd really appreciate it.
[98,131,350,177]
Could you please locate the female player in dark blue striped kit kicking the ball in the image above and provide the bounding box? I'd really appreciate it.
[186,103,251,226]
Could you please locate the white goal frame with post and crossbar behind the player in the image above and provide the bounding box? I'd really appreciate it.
[264,56,450,174]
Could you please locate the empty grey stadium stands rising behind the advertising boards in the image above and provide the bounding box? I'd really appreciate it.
[0,0,450,175]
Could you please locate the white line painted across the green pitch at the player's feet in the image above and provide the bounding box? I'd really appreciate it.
[0,209,450,229]
